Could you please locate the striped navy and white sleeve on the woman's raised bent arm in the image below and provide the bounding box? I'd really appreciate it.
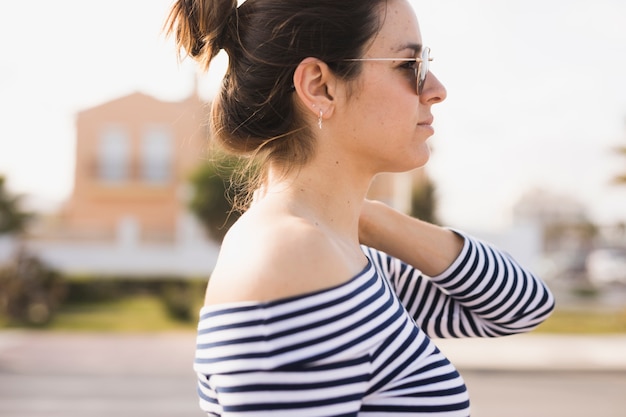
[367,232,554,338]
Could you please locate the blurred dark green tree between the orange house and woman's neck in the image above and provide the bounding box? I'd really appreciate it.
[189,156,245,241]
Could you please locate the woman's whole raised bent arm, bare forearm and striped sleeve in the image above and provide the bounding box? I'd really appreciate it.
[362,197,554,337]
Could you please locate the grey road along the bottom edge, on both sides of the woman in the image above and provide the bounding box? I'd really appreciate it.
[0,371,626,417]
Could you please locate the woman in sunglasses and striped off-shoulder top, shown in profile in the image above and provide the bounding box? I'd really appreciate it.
[168,0,553,417]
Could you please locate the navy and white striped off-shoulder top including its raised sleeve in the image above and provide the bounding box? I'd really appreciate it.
[194,232,554,417]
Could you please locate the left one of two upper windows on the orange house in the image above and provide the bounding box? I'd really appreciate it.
[98,126,130,184]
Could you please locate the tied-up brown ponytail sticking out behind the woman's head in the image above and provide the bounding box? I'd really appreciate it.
[165,0,237,69]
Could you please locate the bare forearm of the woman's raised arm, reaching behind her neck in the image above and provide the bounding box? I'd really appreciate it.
[359,200,464,276]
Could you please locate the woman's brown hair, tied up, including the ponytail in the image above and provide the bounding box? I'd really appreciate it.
[166,0,386,202]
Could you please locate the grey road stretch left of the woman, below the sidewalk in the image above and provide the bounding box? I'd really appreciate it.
[0,374,200,417]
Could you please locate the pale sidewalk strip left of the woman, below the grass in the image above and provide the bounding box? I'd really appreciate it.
[0,330,195,376]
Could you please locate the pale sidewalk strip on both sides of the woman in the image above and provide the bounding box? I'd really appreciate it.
[0,331,626,375]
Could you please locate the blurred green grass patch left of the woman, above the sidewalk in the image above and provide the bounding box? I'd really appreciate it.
[48,296,196,332]
